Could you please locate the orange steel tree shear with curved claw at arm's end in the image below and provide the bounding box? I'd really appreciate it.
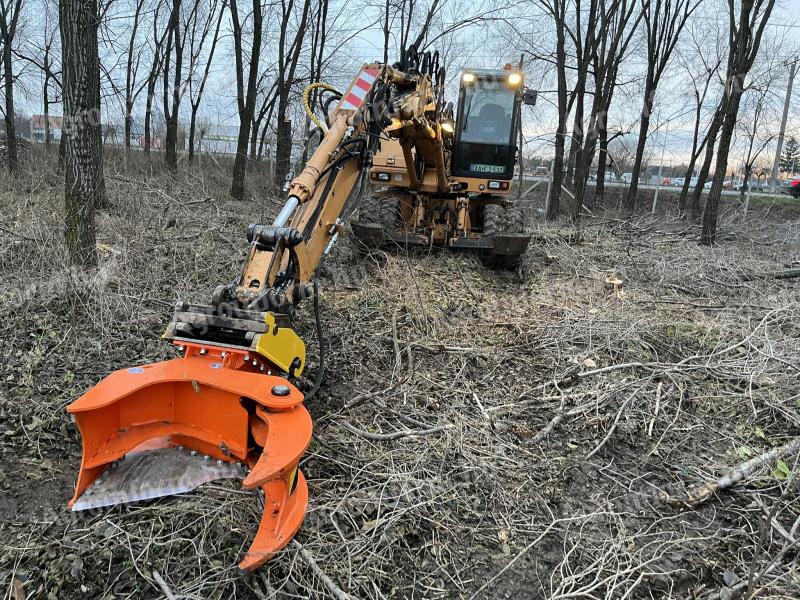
[67,345,311,570]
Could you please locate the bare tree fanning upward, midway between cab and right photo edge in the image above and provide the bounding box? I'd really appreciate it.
[625,0,700,212]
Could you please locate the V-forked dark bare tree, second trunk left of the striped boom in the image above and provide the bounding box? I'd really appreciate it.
[229,0,263,200]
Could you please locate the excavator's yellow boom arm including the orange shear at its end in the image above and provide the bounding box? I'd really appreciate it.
[67,58,448,570]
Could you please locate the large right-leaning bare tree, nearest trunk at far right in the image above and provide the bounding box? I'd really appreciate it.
[700,0,775,245]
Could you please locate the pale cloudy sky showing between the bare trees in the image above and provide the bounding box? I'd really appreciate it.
[18,0,800,171]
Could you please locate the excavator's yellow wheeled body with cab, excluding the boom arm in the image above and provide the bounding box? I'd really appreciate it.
[352,65,536,269]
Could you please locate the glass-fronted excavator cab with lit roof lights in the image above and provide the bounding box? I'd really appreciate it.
[452,69,522,181]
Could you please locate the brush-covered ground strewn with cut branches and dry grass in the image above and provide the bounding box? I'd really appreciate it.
[0,156,800,600]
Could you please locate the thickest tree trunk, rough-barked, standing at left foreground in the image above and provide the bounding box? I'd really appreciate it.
[59,0,105,266]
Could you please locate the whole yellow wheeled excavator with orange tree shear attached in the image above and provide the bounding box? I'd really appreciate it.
[67,48,529,570]
